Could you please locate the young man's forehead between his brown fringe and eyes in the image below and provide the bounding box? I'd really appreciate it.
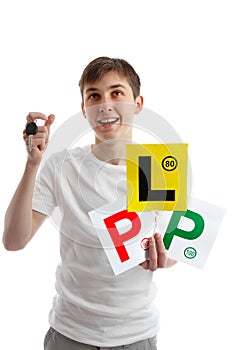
[84,71,131,93]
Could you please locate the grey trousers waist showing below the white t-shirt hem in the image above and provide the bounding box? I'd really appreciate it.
[44,328,157,350]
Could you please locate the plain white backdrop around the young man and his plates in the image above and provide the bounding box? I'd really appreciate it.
[0,0,233,350]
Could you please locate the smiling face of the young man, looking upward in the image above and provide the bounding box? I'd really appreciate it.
[82,71,143,144]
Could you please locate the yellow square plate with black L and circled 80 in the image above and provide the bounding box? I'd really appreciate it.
[126,143,188,211]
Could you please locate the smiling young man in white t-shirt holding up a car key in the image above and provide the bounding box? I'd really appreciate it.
[3,57,175,350]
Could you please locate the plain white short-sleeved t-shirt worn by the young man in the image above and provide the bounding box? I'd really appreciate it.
[33,146,159,347]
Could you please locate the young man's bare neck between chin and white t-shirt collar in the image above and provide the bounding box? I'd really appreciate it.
[92,139,132,165]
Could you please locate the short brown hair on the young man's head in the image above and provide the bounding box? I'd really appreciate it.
[79,56,141,99]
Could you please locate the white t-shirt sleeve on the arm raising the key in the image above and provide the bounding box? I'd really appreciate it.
[32,157,57,216]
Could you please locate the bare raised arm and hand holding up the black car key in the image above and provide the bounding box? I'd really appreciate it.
[3,113,54,250]
